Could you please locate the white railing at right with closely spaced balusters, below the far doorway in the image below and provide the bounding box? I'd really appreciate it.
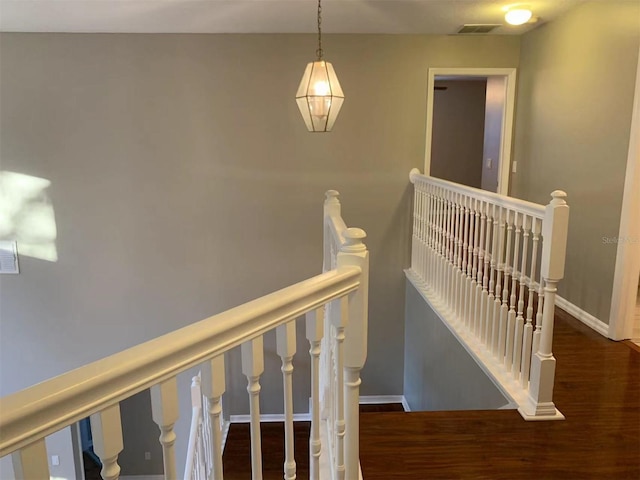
[408,169,569,420]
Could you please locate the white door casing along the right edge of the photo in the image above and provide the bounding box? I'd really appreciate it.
[608,47,640,340]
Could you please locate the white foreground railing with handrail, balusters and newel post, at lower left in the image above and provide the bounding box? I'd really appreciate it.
[0,191,368,480]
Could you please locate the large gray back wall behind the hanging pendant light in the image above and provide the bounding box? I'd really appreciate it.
[0,34,520,476]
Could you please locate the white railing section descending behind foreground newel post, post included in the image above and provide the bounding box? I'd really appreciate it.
[320,190,369,480]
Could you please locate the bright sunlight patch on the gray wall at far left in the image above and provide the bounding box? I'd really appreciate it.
[0,171,58,262]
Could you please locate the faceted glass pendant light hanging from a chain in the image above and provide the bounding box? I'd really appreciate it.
[296,0,344,132]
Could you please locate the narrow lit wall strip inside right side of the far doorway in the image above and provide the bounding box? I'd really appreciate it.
[482,77,507,192]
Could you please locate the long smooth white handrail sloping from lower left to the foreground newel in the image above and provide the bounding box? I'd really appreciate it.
[0,267,362,456]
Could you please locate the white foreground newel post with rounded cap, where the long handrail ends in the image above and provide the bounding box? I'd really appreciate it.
[338,228,369,479]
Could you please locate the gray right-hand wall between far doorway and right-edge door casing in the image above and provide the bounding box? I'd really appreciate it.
[512,1,640,323]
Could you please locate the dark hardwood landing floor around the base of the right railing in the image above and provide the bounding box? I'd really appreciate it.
[360,311,640,480]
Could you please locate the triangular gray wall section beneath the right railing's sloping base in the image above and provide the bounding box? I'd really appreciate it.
[404,280,509,411]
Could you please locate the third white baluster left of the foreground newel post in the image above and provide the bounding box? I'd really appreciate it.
[276,321,296,480]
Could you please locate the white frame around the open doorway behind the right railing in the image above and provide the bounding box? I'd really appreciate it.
[424,68,516,195]
